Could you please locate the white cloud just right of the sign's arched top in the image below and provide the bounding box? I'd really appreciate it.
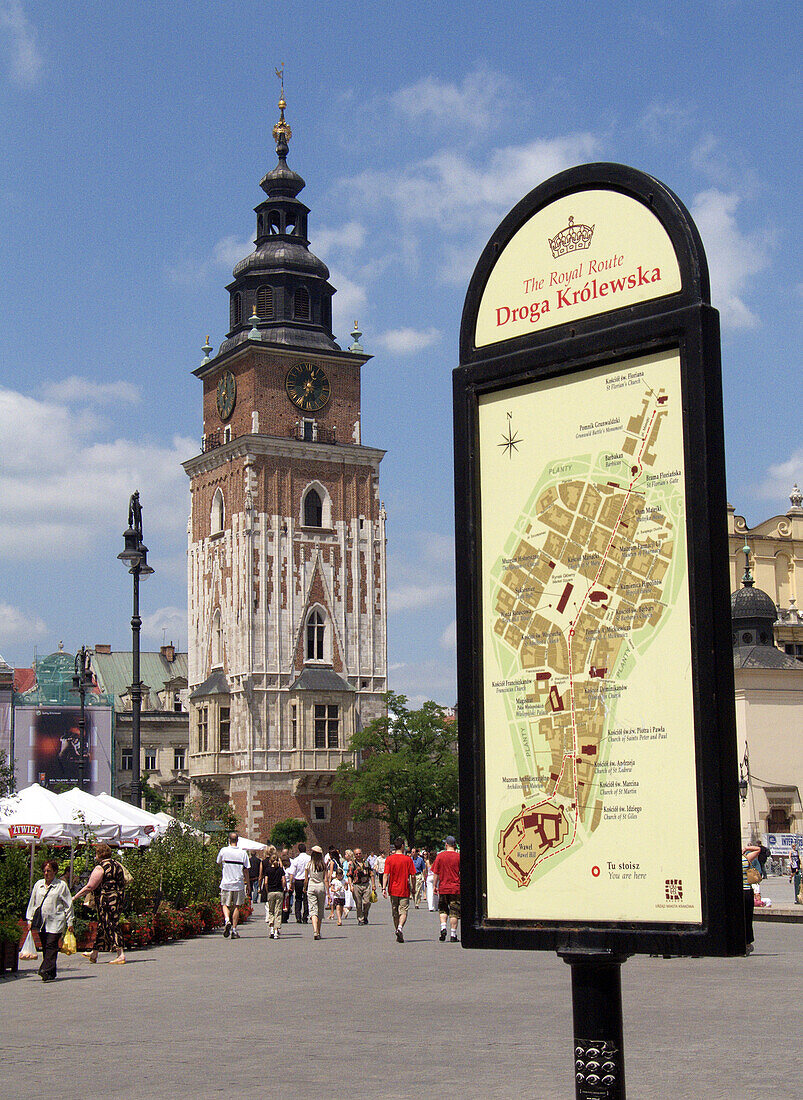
[692,188,770,329]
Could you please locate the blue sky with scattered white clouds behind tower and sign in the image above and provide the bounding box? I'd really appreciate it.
[0,0,803,705]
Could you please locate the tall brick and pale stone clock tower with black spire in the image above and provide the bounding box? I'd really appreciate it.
[184,87,387,846]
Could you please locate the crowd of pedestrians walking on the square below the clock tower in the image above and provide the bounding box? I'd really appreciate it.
[218,833,460,944]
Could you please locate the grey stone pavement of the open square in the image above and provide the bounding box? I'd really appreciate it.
[0,902,803,1100]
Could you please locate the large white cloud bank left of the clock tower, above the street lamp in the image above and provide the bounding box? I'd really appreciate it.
[0,389,197,560]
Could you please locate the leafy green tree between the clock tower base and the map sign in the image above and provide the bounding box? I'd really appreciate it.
[334,692,458,846]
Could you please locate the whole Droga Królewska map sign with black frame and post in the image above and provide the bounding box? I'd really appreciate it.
[453,164,745,1100]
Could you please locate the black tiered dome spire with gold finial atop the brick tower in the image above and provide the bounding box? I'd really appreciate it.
[220,69,340,352]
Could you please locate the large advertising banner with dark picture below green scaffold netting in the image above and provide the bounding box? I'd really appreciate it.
[14,706,112,794]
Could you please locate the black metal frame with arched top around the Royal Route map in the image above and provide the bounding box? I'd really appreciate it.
[453,164,745,956]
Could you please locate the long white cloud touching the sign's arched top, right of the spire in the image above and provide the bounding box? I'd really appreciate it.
[349,133,598,233]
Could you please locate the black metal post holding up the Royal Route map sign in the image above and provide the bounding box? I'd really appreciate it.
[558,950,627,1100]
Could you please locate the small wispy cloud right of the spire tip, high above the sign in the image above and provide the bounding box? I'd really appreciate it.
[391,68,508,133]
